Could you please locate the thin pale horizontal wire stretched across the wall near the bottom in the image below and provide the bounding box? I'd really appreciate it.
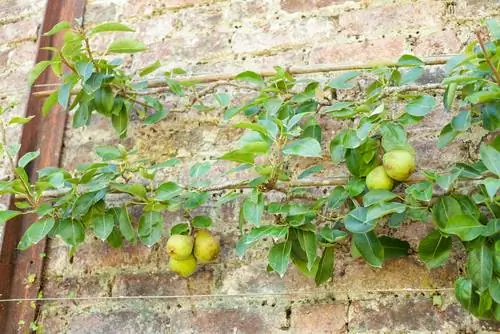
[0,287,454,303]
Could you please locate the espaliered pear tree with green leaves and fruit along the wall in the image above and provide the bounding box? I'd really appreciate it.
[0,20,500,320]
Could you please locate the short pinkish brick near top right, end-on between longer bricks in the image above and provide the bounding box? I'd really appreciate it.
[413,30,462,57]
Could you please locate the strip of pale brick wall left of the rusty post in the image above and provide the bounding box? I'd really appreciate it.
[0,0,46,246]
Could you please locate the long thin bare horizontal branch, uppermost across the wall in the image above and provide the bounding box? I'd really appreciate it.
[33,56,452,96]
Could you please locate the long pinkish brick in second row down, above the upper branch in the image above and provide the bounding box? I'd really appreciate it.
[310,37,405,65]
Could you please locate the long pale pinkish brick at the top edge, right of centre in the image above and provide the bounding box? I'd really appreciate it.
[339,1,441,36]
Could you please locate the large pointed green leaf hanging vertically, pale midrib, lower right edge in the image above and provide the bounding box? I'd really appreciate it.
[467,240,493,292]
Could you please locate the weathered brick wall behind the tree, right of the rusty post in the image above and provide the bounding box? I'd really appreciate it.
[8,0,500,333]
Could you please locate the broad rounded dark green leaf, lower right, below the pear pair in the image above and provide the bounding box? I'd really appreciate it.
[418,230,452,269]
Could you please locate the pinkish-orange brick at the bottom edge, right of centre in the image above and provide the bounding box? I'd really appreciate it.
[290,303,348,334]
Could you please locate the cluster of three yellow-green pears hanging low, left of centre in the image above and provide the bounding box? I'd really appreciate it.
[166,230,220,277]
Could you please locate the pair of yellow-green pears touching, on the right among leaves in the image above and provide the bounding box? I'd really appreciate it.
[366,150,416,190]
